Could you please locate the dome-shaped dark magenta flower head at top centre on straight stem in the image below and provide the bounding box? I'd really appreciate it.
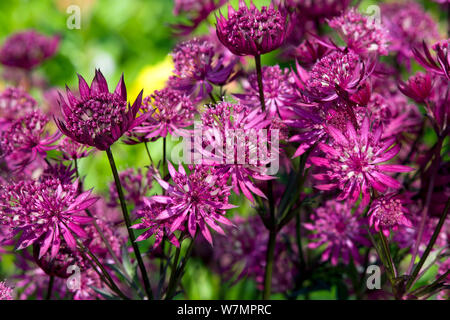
[216,0,289,56]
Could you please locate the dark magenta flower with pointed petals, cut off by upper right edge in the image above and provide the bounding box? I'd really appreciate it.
[412,39,450,81]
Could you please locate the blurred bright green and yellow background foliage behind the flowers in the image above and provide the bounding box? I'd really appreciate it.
[0,0,445,299]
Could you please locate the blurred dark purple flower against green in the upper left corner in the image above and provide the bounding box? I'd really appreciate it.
[0,30,59,70]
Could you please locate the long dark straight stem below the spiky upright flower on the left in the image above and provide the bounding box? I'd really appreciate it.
[106,148,153,299]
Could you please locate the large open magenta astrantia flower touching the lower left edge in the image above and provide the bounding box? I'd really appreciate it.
[0,179,97,258]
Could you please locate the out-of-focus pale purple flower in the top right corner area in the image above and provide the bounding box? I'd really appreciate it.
[380,1,439,66]
